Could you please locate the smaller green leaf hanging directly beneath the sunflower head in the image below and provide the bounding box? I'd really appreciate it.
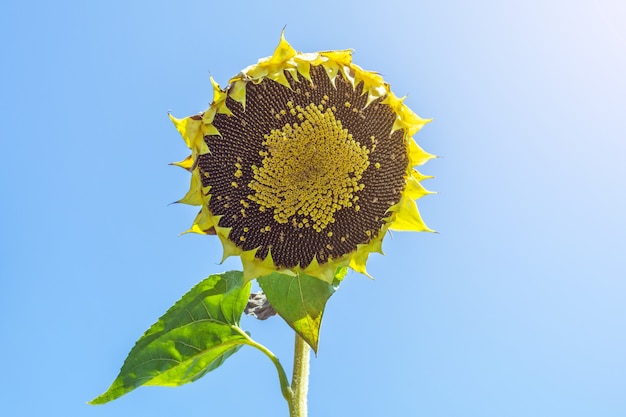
[257,268,347,353]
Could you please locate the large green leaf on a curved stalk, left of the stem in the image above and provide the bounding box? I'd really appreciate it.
[90,271,250,404]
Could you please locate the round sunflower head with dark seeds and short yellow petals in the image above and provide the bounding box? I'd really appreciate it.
[170,34,433,283]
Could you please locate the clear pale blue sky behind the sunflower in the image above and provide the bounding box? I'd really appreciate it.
[0,0,626,417]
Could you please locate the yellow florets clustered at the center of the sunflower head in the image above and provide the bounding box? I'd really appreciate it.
[248,97,370,232]
